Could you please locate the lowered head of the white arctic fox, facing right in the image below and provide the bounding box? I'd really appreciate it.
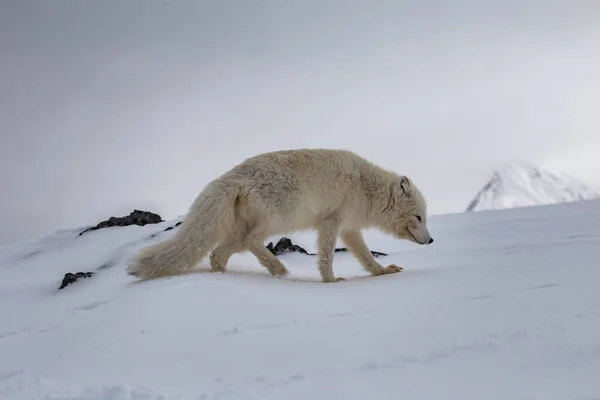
[383,176,433,244]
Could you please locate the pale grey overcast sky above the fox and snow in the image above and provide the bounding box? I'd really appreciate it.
[0,0,600,243]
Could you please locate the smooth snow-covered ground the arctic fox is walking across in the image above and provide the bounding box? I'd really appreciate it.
[0,201,600,400]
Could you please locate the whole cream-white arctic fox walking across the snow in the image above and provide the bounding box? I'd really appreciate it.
[128,149,433,282]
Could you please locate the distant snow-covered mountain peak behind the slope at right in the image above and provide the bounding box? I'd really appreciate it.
[467,162,600,211]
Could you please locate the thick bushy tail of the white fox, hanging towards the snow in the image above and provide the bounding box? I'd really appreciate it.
[127,181,239,279]
